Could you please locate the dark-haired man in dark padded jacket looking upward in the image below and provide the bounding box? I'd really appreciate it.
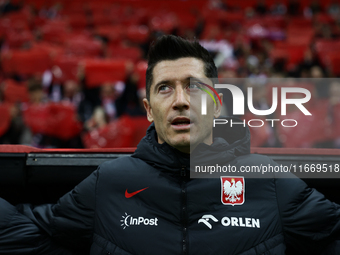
[0,36,340,255]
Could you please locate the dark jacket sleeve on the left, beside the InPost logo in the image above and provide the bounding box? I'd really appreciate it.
[9,169,99,252]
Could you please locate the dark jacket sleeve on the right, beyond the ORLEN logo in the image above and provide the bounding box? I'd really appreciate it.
[275,174,340,254]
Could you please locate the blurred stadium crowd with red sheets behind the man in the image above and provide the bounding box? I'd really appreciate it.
[0,0,340,148]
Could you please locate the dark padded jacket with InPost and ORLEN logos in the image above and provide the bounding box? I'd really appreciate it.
[0,122,340,255]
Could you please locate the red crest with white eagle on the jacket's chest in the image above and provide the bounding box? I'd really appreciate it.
[221,176,244,206]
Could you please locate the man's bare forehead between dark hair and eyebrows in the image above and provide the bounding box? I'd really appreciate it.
[151,58,207,86]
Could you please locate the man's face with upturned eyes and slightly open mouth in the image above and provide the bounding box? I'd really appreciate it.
[143,58,222,153]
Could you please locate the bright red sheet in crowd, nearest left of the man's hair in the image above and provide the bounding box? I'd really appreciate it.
[85,59,128,88]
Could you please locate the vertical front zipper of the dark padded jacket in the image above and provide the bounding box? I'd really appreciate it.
[181,166,188,255]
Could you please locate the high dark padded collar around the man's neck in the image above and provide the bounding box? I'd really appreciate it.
[132,118,250,171]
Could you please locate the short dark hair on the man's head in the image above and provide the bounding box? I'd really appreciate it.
[146,35,217,102]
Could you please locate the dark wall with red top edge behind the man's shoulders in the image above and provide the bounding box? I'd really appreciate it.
[0,146,340,204]
